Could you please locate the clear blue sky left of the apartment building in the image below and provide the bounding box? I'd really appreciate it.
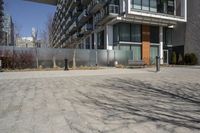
[4,0,55,36]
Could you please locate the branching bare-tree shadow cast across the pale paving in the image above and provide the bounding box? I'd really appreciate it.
[71,78,200,130]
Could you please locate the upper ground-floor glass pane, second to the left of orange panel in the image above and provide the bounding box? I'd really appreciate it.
[119,23,131,42]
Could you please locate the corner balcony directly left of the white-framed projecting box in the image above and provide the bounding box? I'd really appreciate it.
[94,4,119,25]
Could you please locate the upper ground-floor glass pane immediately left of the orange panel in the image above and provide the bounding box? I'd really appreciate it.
[131,24,141,42]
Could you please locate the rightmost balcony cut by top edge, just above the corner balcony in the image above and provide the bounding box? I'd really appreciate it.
[88,0,109,14]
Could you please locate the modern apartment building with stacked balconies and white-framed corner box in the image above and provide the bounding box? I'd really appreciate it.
[28,0,187,64]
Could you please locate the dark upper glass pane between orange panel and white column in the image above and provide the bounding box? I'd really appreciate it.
[150,26,159,43]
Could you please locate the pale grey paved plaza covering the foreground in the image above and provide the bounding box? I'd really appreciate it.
[0,68,200,133]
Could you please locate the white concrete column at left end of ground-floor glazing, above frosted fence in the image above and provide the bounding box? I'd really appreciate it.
[105,25,113,50]
